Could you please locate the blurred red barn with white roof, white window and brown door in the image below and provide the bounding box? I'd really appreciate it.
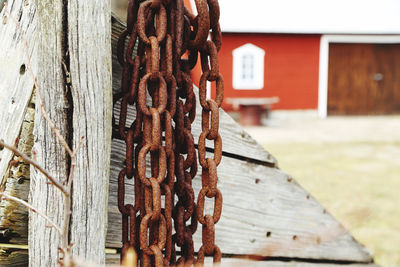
[187,0,400,117]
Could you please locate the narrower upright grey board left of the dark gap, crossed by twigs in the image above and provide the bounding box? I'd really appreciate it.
[30,0,68,267]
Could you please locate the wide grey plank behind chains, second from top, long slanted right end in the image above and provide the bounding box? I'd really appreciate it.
[106,139,372,262]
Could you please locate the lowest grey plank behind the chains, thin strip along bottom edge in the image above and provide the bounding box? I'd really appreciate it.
[106,254,379,267]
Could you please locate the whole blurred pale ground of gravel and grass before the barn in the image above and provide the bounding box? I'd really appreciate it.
[241,111,400,267]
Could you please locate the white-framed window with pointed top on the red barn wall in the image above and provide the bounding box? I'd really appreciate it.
[233,44,265,90]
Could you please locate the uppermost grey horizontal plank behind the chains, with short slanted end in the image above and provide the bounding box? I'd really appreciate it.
[112,17,277,165]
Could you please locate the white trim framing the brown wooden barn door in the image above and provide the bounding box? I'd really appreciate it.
[318,35,400,118]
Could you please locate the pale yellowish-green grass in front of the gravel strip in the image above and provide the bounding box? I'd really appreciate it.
[264,142,400,267]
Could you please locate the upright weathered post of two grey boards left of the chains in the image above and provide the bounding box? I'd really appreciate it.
[29,0,112,266]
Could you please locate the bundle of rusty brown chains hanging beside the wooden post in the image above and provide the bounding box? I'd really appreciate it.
[114,0,224,266]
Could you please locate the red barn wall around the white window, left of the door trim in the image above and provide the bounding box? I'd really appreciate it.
[193,33,320,109]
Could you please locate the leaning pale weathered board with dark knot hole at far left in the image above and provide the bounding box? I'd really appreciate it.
[0,0,37,184]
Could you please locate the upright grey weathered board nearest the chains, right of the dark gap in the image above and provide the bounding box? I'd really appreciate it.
[67,0,112,263]
